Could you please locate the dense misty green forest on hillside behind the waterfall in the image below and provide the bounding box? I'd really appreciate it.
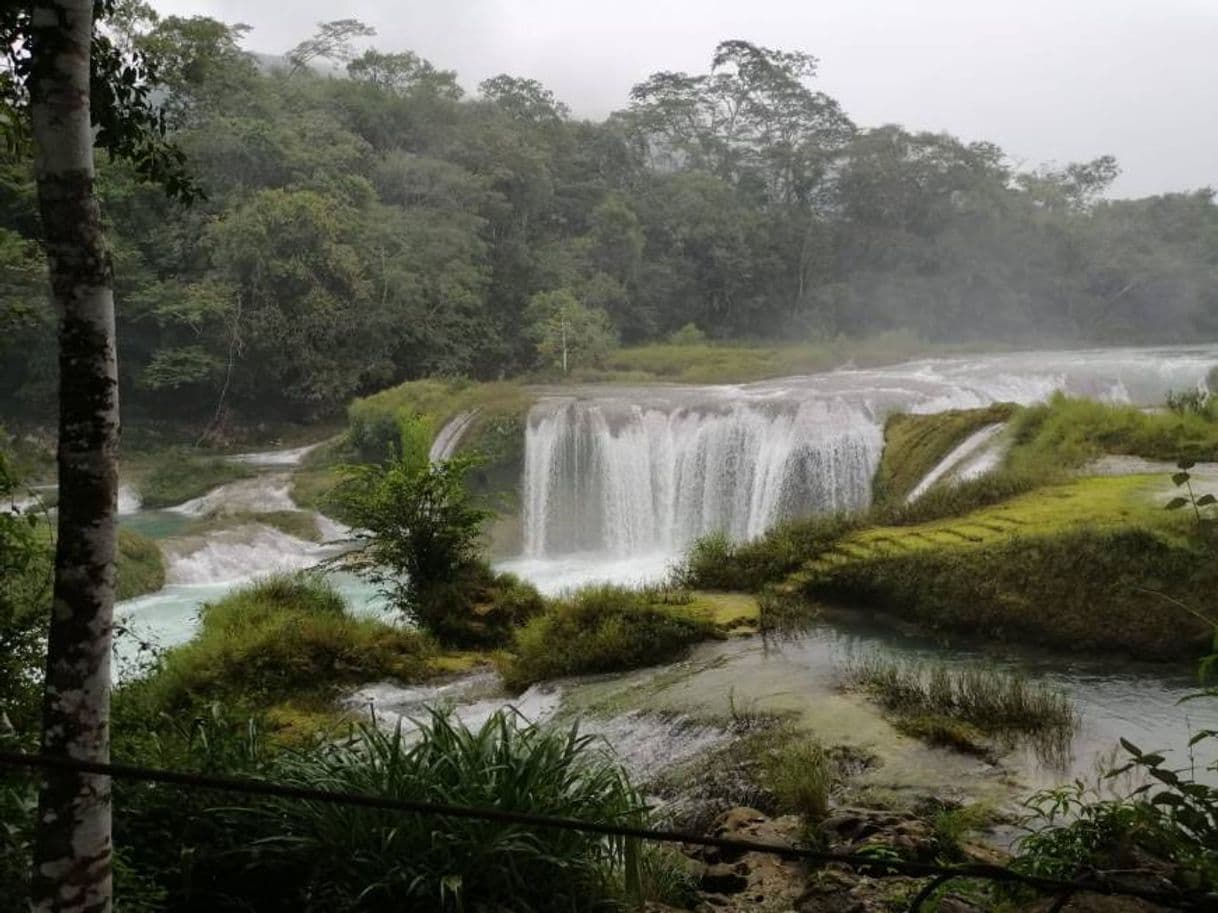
[7,4,1218,422]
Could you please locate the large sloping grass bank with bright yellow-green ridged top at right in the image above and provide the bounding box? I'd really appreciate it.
[778,476,1218,659]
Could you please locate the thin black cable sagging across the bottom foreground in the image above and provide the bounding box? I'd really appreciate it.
[0,751,1218,911]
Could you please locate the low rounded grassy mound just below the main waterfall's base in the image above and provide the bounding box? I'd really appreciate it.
[503,584,720,689]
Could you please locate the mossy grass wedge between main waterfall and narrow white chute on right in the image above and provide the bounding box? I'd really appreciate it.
[872,403,1016,504]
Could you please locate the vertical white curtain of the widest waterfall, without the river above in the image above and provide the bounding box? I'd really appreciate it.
[524,399,883,556]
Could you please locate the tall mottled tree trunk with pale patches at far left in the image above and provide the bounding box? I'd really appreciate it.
[29,0,118,913]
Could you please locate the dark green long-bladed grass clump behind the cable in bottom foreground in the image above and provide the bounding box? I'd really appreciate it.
[222,712,648,913]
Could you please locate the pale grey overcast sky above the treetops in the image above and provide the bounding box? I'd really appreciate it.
[151,0,1218,196]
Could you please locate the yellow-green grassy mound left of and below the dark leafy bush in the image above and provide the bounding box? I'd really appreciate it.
[141,575,436,711]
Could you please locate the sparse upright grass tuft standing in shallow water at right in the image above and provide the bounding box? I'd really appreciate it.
[843,652,1078,746]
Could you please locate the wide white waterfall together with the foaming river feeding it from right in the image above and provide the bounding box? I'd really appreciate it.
[512,347,1218,569]
